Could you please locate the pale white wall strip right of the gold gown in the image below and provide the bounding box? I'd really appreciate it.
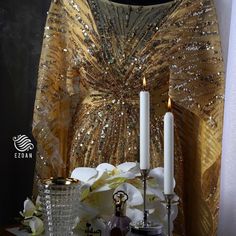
[216,0,236,236]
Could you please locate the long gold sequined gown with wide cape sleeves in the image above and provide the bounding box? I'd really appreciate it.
[33,0,224,236]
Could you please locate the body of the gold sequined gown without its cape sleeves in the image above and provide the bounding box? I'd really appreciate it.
[66,0,179,169]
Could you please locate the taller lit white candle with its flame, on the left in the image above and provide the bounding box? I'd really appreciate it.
[140,78,150,170]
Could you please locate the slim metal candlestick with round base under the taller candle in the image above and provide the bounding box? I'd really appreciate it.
[130,170,162,236]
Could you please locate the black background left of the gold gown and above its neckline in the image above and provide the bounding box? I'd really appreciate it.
[0,0,171,226]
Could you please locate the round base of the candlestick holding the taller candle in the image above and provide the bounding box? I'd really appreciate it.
[130,221,162,236]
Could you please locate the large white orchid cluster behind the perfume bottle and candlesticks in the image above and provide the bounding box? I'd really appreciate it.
[71,162,178,235]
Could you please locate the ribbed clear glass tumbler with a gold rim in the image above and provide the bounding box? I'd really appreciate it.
[39,178,80,236]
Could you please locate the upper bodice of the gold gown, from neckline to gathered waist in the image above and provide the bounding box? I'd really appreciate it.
[71,0,178,103]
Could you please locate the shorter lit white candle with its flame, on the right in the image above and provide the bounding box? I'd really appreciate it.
[164,99,174,194]
